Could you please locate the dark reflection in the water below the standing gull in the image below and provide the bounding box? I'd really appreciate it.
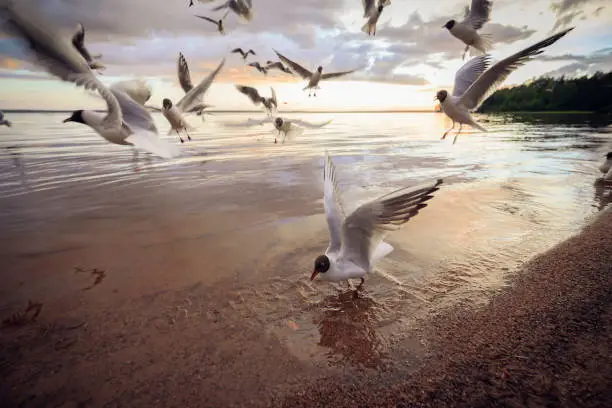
[315,290,384,368]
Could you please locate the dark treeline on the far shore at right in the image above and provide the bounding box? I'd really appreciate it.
[478,72,612,113]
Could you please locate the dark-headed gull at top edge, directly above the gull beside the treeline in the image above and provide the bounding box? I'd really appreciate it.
[442,0,492,58]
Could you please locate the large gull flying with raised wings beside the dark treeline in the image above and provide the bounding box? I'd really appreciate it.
[434,27,574,144]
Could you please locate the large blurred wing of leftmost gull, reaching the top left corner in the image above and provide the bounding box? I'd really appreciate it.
[0,2,122,129]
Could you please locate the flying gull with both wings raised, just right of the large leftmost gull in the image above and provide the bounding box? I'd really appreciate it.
[161,55,225,143]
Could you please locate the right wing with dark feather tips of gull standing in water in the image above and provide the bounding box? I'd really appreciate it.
[340,180,442,271]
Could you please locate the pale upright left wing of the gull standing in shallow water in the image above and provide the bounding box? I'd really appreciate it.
[323,152,344,253]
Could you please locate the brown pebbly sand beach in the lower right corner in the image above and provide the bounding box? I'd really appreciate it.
[281,210,612,407]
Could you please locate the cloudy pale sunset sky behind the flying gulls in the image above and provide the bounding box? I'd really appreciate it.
[0,0,612,111]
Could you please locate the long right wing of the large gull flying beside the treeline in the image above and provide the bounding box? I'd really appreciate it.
[459,27,574,110]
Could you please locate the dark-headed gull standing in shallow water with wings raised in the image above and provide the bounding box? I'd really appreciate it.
[310,154,443,289]
